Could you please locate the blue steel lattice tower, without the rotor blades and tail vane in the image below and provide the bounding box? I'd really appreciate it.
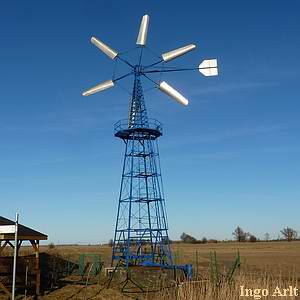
[112,66,172,267]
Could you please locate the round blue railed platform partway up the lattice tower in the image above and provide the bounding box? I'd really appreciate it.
[114,119,162,140]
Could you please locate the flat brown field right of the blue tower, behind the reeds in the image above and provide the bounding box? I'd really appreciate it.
[173,241,300,279]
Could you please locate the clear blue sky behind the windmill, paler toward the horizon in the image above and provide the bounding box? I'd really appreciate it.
[0,0,300,244]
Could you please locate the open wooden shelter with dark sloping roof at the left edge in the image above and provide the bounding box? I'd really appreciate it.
[0,216,48,295]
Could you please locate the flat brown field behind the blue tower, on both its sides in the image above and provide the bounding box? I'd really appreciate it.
[41,241,300,279]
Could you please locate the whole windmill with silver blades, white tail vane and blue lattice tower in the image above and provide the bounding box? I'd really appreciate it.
[83,15,218,275]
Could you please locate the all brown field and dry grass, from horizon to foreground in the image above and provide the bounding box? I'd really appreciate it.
[0,241,300,300]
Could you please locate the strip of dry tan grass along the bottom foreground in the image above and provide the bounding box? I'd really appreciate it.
[15,272,299,300]
